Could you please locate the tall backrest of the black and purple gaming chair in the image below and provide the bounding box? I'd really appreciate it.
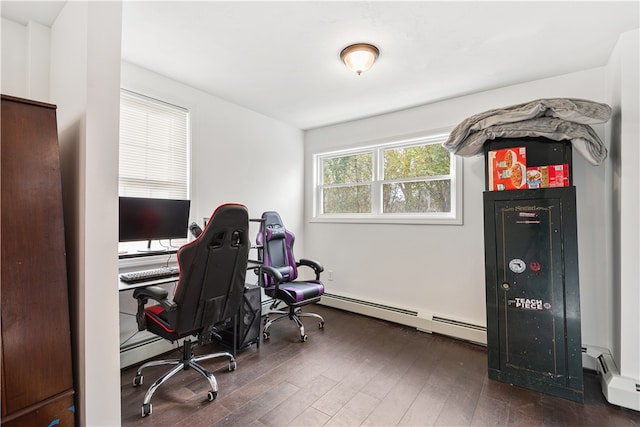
[256,211,298,287]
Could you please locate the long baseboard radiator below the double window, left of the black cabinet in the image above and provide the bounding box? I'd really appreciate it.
[320,293,487,345]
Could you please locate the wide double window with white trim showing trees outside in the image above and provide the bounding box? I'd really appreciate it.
[313,134,462,224]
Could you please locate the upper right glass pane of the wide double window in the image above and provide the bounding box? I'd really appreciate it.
[384,144,451,180]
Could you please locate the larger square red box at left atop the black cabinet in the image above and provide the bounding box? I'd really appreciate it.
[487,147,527,191]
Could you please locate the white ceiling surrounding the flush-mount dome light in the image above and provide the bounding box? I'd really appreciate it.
[2,0,640,129]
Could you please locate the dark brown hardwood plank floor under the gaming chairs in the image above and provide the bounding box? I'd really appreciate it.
[121,306,640,426]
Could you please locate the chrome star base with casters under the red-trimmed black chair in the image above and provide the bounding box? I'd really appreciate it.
[133,339,237,417]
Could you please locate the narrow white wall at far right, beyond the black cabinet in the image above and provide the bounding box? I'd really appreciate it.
[607,30,640,380]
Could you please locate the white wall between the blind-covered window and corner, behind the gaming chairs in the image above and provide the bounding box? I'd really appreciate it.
[122,63,304,256]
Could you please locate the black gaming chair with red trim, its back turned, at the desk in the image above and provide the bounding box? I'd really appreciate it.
[133,204,250,417]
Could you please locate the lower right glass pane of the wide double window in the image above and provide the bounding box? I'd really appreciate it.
[382,180,451,213]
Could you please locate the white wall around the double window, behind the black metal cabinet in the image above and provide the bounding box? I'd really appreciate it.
[305,68,612,348]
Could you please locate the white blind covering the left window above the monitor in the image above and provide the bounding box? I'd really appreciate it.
[119,90,189,199]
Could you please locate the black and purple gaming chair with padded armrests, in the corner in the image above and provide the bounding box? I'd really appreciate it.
[256,212,324,341]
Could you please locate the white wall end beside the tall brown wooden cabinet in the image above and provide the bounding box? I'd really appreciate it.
[50,2,122,426]
